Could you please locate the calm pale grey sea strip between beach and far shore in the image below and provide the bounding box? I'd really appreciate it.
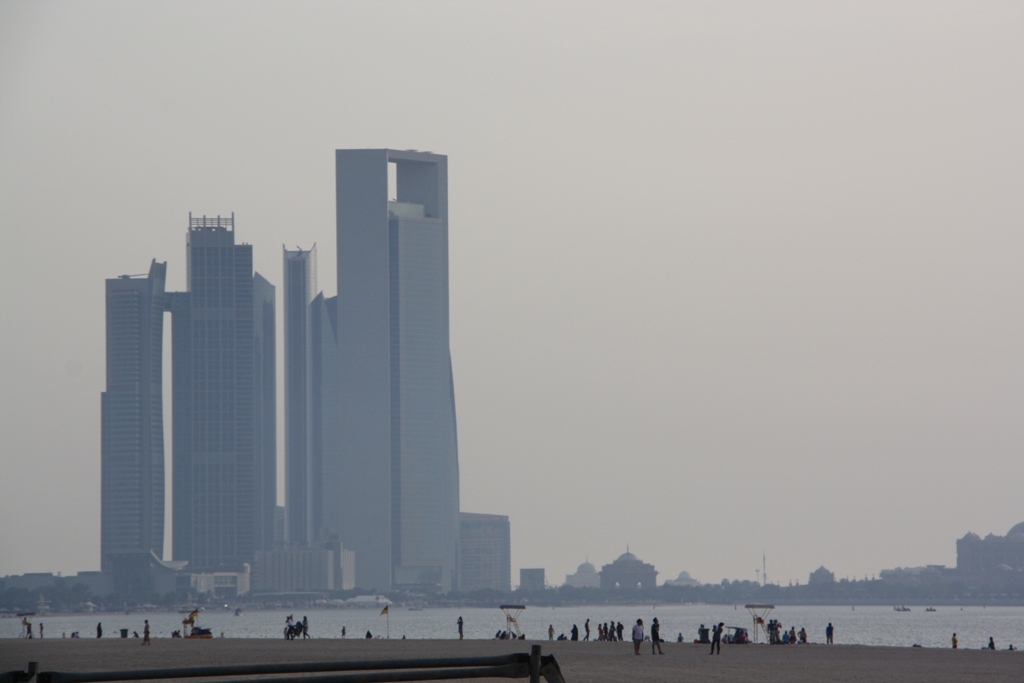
[0,605,1024,649]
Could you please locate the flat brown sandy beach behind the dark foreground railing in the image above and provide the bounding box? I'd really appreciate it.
[0,638,1024,683]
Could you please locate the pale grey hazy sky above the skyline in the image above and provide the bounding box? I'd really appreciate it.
[0,0,1024,584]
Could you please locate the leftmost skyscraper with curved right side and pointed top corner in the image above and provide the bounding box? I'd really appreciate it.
[100,261,167,571]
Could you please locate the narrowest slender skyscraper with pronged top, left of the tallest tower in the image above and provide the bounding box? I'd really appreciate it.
[284,245,316,546]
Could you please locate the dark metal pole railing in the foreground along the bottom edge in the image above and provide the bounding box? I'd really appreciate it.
[24,645,565,683]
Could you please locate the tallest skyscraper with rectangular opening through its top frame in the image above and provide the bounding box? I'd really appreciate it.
[335,150,459,591]
